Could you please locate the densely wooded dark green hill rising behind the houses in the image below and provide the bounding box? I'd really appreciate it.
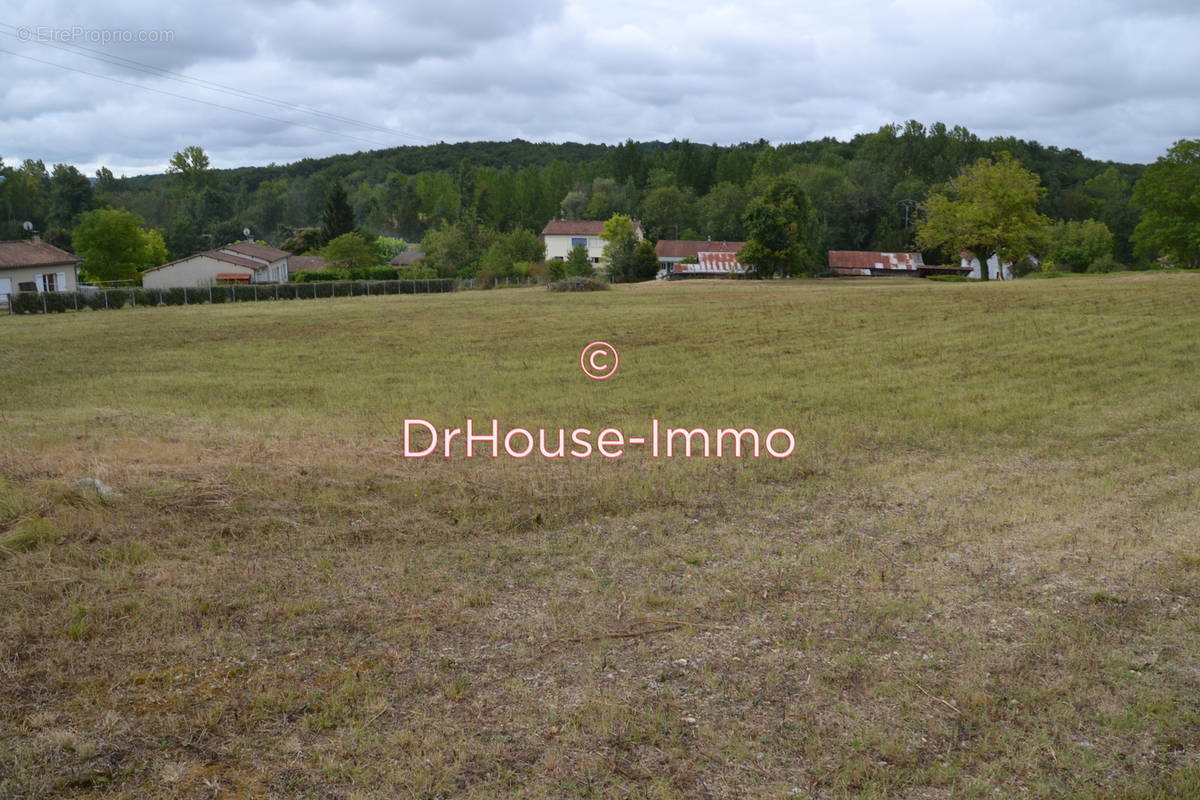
[0,121,1144,264]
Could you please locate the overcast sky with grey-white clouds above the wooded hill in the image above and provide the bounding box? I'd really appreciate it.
[0,0,1200,174]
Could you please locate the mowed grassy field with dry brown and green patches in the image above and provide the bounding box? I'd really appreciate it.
[0,275,1200,800]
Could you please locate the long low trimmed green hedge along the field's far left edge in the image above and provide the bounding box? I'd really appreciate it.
[8,278,455,314]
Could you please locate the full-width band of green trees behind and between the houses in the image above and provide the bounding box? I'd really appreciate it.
[0,121,1195,284]
